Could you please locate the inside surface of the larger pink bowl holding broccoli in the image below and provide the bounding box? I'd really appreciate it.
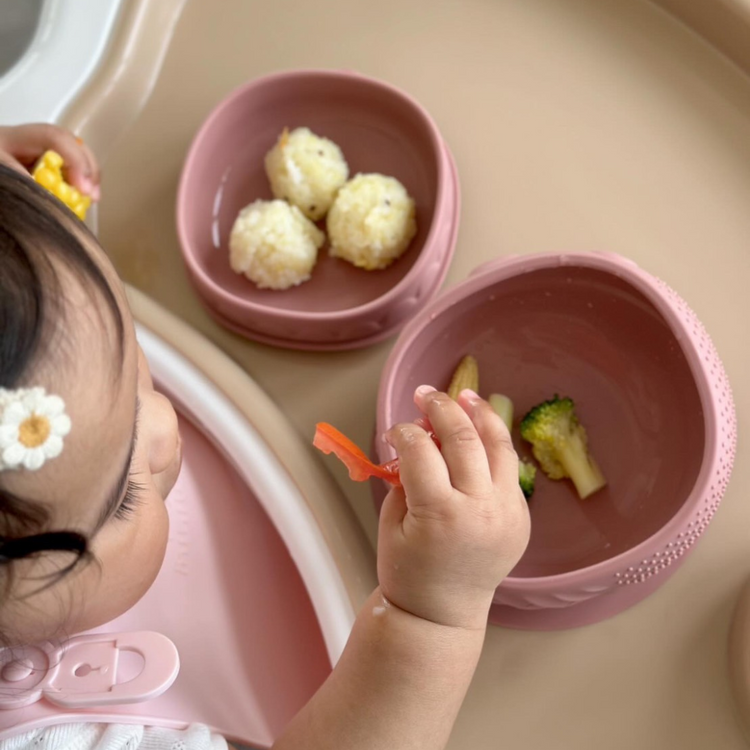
[385,267,705,578]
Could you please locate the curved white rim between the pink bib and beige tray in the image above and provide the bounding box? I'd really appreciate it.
[136,325,355,665]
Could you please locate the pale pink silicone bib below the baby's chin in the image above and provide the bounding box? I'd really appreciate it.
[0,418,331,747]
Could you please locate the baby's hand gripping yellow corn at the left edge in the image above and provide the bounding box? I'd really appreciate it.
[0,123,99,201]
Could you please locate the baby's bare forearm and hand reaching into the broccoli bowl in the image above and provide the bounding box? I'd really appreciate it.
[274,388,529,750]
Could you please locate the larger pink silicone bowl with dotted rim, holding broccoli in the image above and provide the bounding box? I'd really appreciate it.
[375,253,736,630]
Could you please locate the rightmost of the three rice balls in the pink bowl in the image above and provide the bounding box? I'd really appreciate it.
[327,174,417,271]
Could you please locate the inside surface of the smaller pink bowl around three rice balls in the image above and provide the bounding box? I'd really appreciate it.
[178,74,441,320]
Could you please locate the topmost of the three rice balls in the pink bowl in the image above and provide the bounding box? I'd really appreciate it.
[266,128,349,221]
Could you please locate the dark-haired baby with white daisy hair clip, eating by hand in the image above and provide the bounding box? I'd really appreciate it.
[0,125,529,750]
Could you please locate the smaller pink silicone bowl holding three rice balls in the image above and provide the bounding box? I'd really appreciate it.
[177,70,459,350]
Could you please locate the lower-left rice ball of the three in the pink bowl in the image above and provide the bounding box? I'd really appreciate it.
[229,200,325,289]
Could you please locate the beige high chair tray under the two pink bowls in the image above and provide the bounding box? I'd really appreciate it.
[53,0,750,750]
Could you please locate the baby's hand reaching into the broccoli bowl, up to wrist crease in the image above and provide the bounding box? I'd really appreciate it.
[378,386,530,628]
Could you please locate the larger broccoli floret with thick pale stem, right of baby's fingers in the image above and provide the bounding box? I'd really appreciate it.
[521,395,607,498]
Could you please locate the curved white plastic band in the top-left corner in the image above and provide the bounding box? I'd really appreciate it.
[0,0,123,125]
